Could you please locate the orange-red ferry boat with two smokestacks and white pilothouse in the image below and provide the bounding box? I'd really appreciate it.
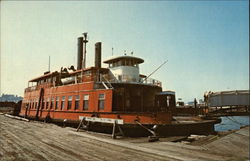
[20,33,219,135]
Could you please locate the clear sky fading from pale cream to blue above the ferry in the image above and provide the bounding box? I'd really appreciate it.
[0,0,249,101]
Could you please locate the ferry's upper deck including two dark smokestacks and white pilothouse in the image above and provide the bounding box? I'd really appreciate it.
[25,34,161,92]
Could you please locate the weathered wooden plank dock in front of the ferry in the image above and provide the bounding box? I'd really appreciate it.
[0,115,249,161]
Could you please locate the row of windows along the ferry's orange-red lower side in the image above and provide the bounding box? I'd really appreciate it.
[26,94,105,110]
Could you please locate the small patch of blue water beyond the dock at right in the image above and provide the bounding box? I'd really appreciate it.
[215,116,250,131]
